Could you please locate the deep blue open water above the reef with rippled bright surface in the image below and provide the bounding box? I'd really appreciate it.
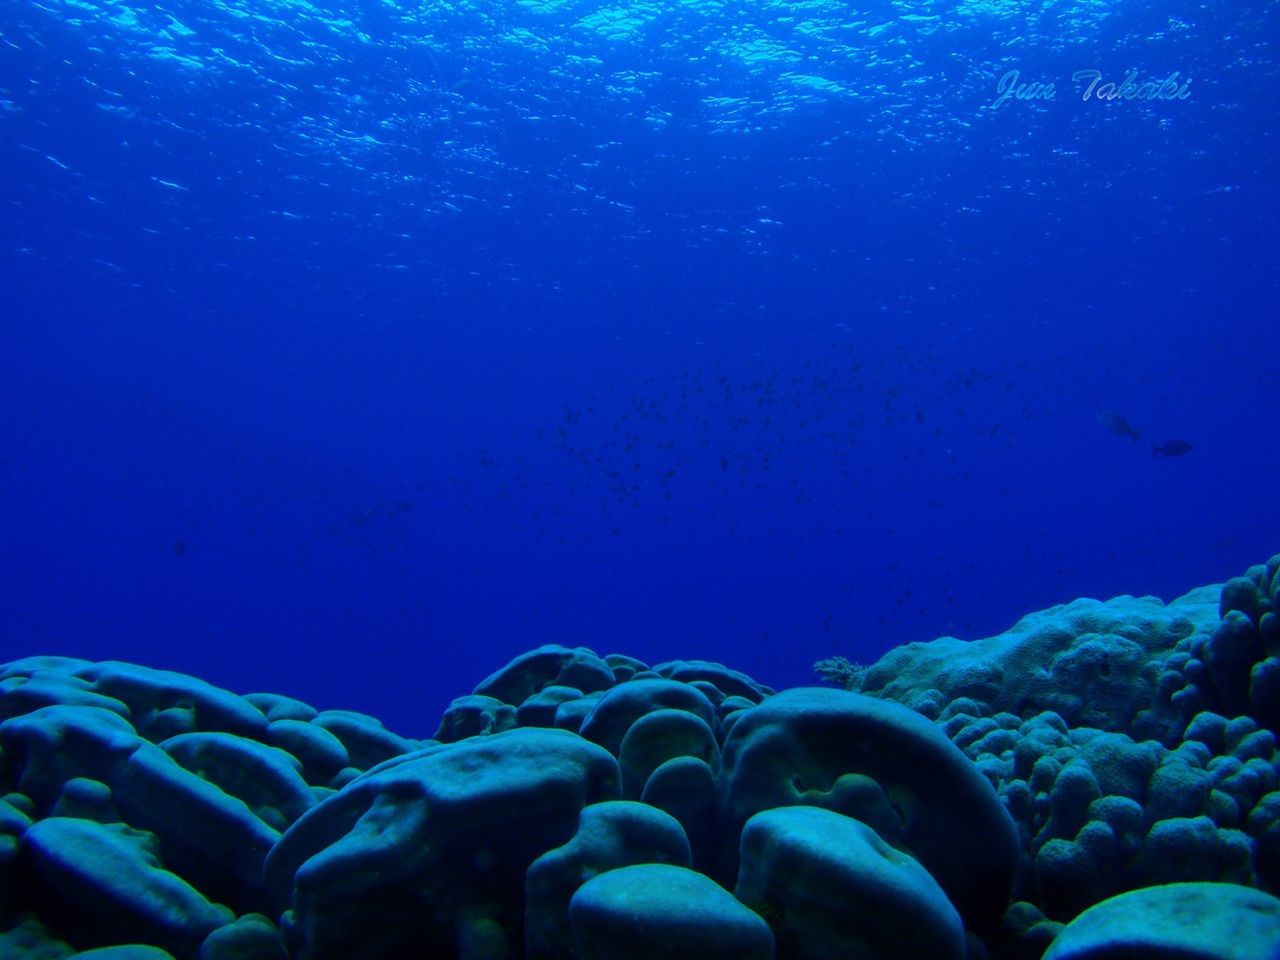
[0,0,1280,736]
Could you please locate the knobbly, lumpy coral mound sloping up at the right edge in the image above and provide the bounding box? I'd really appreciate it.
[854,557,1280,931]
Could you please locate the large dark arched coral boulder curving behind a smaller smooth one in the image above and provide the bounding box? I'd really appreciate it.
[721,687,1019,927]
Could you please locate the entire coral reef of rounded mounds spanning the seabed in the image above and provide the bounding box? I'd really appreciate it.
[0,557,1280,960]
